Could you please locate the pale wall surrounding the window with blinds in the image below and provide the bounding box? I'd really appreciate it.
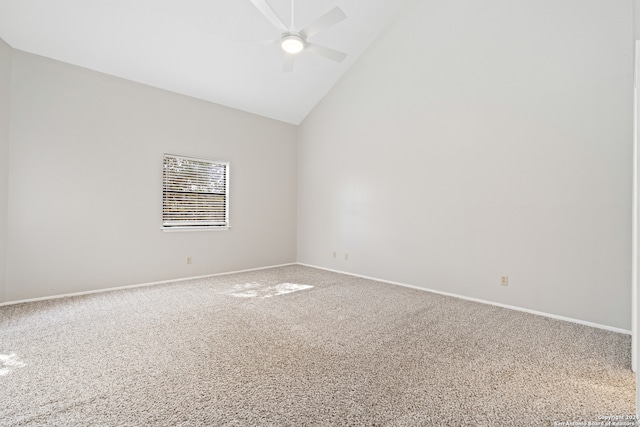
[5,51,296,301]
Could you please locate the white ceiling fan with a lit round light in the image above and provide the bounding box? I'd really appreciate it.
[251,0,347,71]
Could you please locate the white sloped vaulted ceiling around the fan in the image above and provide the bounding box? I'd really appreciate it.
[0,0,407,124]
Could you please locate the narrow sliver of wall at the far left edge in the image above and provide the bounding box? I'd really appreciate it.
[0,39,12,301]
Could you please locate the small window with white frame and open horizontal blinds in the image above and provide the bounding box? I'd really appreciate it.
[162,154,229,229]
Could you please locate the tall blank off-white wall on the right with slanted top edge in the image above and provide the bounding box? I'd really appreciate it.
[298,0,633,330]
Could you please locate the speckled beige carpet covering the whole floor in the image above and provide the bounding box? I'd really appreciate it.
[0,266,635,426]
